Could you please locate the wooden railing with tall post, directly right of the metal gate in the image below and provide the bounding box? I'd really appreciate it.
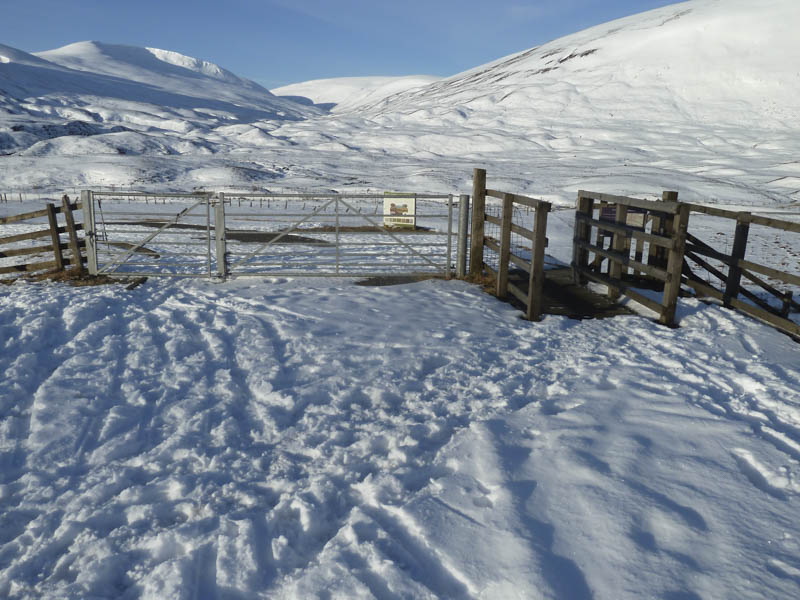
[470,169,551,321]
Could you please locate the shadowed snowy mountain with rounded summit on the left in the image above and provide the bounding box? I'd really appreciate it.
[0,42,318,156]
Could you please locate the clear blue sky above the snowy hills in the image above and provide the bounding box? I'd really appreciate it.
[0,0,675,88]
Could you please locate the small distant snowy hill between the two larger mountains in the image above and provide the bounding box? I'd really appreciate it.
[271,75,441,112]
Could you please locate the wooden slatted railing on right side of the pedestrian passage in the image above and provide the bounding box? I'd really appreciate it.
[572,191,689,326]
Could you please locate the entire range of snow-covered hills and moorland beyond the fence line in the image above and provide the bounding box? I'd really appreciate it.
[0,0,800,206]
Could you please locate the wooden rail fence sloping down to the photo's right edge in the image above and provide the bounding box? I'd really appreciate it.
[682,204,800,338]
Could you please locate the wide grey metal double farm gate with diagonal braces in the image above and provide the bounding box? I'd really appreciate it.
[82,191,462,277]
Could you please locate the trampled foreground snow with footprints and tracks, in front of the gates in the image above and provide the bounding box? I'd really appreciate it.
[0,279,800,599]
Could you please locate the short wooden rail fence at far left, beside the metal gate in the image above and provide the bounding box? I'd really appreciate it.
[0,196,86,275]
